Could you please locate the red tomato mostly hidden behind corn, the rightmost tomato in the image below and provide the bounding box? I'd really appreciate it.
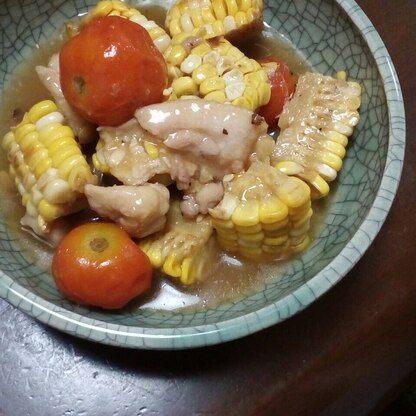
[259,56,296,127]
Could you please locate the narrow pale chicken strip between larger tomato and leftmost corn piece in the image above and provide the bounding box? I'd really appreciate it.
[36,54,97,144]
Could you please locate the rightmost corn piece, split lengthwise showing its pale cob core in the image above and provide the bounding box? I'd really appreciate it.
[271,72,361,199]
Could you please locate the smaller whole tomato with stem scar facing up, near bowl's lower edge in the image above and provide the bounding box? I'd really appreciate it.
[52,222,152,309]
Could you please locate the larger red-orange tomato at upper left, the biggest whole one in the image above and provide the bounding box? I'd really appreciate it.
[59,16,168,126]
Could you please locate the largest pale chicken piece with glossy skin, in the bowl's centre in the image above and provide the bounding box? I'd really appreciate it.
[135,99,267,189]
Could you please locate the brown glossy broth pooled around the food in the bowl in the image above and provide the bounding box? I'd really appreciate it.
[0,7,310,310]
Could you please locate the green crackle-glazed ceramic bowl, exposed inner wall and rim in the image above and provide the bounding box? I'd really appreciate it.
[0,0,405,349]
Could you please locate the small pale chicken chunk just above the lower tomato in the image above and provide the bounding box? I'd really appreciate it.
[85,184,169,237]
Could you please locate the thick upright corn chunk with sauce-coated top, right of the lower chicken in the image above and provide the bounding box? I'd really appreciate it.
[209,162,312,260]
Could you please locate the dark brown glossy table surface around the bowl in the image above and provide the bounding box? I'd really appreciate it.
[0,0,416,416]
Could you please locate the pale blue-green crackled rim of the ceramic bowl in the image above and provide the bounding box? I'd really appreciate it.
[0,0,406,350]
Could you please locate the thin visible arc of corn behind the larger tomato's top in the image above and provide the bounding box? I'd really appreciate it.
[82,0,171,53]
